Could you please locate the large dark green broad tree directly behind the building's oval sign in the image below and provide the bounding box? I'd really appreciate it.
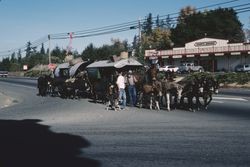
[171,8,244,47]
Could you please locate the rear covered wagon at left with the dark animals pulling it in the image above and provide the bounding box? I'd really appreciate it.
[38,61,90,98]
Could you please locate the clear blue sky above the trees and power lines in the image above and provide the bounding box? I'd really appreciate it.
[0,0,250,58]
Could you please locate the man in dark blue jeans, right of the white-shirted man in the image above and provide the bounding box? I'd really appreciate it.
[127,70,137,106]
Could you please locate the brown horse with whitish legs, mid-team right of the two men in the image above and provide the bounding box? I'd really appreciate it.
[162,79,183,111]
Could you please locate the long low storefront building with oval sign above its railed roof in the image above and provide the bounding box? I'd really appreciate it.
[145,38,250,72]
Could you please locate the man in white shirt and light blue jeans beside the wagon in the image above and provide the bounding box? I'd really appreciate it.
[116,72,126,110]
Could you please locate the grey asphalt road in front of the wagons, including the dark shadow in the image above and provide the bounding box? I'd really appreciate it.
[0,77,250,167]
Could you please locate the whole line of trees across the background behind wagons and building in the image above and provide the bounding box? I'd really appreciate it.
[0,6,246,71]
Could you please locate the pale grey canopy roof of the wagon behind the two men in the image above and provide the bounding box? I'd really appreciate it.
[87,58,142,69]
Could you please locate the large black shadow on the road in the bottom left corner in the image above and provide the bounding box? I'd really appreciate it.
[0,120,100,167]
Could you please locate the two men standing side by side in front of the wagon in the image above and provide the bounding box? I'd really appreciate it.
[116,70,137,110]
